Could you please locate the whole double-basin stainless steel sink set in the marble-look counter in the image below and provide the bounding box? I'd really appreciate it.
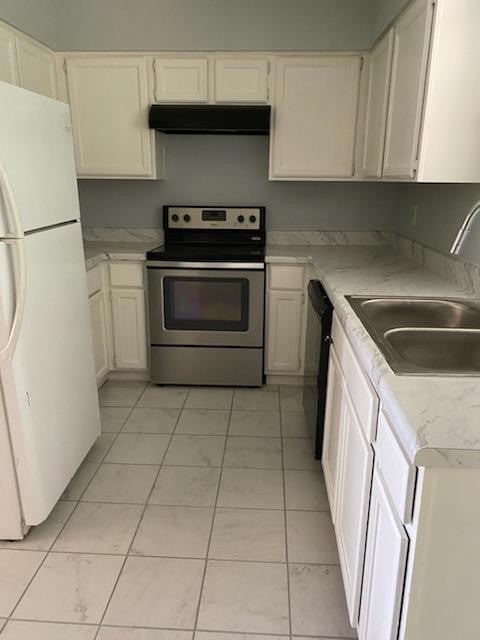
[347,296,480,376]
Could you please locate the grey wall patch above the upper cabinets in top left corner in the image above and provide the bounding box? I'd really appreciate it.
[0,0,56,49]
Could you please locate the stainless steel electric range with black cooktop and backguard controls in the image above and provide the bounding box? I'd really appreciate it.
[147,206,265,386]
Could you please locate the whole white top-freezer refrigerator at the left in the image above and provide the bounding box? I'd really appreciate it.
[0,82,100,540]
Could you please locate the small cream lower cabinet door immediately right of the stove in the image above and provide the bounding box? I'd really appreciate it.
[267,291,305,374]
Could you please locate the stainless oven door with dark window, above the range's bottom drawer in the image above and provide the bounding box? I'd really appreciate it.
[148,263,265,347]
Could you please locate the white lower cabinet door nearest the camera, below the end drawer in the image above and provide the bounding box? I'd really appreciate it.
[358,470,408,640]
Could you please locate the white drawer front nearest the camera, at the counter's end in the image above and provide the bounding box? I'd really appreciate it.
[374,411,416,523]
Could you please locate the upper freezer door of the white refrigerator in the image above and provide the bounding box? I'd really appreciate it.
[0,82,80,238]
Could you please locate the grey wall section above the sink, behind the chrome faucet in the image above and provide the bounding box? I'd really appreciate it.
[395,184,480,264]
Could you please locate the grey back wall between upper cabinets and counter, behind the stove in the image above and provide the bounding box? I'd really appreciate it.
[79,135,399,230]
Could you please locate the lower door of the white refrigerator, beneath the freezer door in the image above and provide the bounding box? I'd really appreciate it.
[0,223,100,526]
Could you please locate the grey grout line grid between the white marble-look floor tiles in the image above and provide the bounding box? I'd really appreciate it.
[0,384,343,640]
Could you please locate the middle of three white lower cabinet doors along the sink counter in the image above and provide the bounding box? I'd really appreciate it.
[334,389,380,624]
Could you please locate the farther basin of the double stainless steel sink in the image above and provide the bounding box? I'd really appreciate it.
[352,297,480,329]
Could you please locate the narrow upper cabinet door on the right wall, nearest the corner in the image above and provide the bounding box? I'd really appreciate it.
[363,29,394,178]
